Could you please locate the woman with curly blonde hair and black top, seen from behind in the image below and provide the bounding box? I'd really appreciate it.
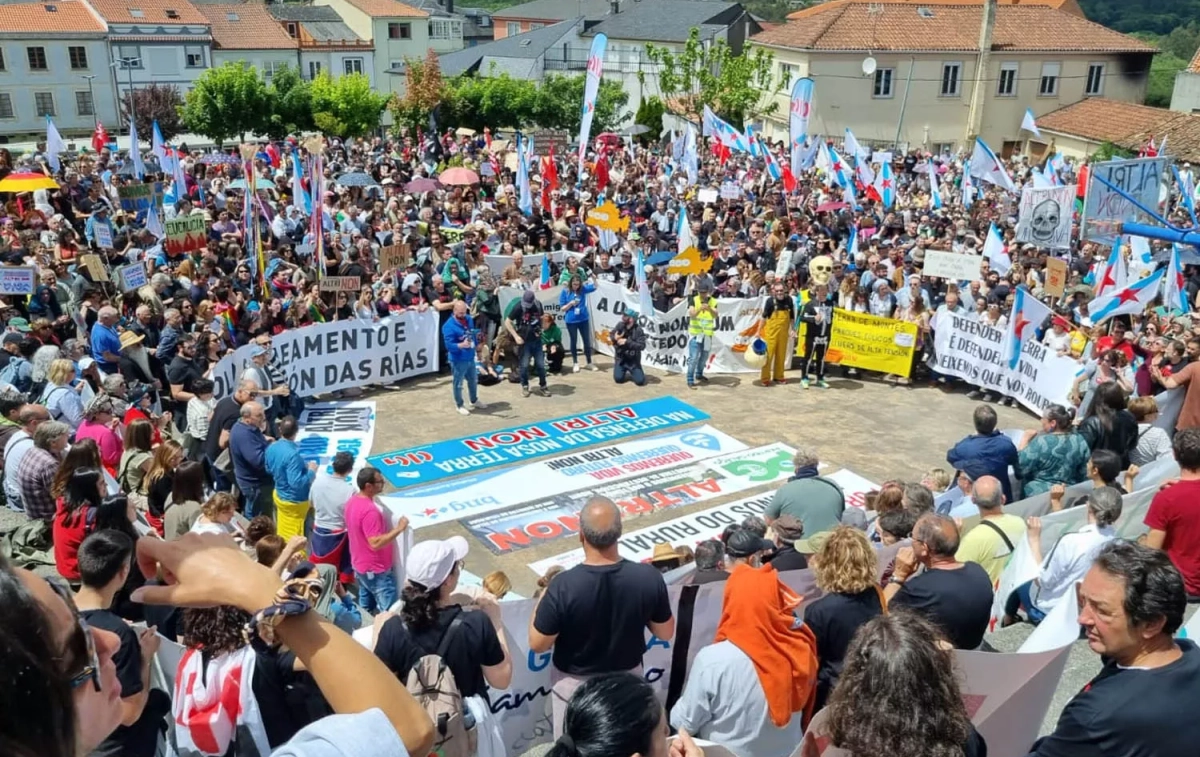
[804,527,888,710]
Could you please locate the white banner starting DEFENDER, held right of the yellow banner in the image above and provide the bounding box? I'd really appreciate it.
[934,313,1080,415]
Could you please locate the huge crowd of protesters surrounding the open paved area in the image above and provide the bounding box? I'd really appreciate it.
[0,112,1200,757]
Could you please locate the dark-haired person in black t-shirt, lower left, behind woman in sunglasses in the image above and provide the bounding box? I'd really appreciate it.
[76,529,170,757]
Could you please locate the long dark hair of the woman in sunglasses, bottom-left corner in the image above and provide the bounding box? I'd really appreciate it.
[0,553,77,757]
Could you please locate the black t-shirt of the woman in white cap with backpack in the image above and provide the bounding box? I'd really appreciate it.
[374,605,504,697]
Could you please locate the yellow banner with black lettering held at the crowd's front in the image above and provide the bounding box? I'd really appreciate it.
[825,308,917,377]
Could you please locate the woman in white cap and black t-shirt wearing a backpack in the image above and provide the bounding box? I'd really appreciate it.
[374,536,512,757]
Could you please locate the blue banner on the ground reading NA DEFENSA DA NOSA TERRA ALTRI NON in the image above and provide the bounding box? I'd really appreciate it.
[371,397,708,488]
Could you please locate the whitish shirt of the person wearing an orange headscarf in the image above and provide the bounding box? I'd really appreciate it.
[671,642,804,757]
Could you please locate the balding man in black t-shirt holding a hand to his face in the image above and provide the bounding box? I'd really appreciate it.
[883,512,992,649]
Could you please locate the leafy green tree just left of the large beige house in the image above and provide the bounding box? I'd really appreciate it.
[638,29,786,127]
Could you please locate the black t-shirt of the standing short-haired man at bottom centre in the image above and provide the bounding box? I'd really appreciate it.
[533,560,671,675]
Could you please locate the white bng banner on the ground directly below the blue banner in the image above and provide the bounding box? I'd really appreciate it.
[380,426,748,529]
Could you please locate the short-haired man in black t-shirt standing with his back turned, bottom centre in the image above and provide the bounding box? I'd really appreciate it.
[529,497,674,737]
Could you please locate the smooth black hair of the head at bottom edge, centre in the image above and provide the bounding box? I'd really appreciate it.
[546,673,662,757]
